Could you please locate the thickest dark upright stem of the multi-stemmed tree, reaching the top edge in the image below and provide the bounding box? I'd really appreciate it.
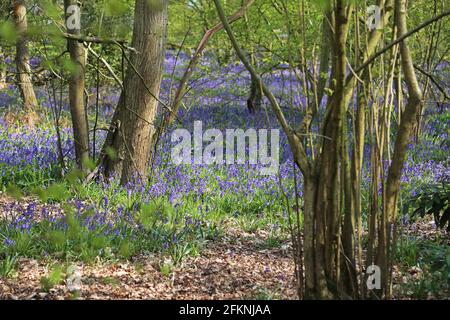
[315,1,351,298]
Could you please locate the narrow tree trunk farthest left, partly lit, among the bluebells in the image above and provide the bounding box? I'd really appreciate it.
[13,0,38,110]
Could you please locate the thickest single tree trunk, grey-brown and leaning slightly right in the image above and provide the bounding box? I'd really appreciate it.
[103,0,168,184]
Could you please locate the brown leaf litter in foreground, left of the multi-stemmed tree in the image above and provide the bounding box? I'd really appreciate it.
[0,195,296,300]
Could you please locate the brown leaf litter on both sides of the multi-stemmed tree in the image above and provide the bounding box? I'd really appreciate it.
[0,197,450,300]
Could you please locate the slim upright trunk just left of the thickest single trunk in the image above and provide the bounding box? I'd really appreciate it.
[64,0,89,169]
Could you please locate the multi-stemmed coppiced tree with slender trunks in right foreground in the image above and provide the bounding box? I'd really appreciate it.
[214,0,450,298]
